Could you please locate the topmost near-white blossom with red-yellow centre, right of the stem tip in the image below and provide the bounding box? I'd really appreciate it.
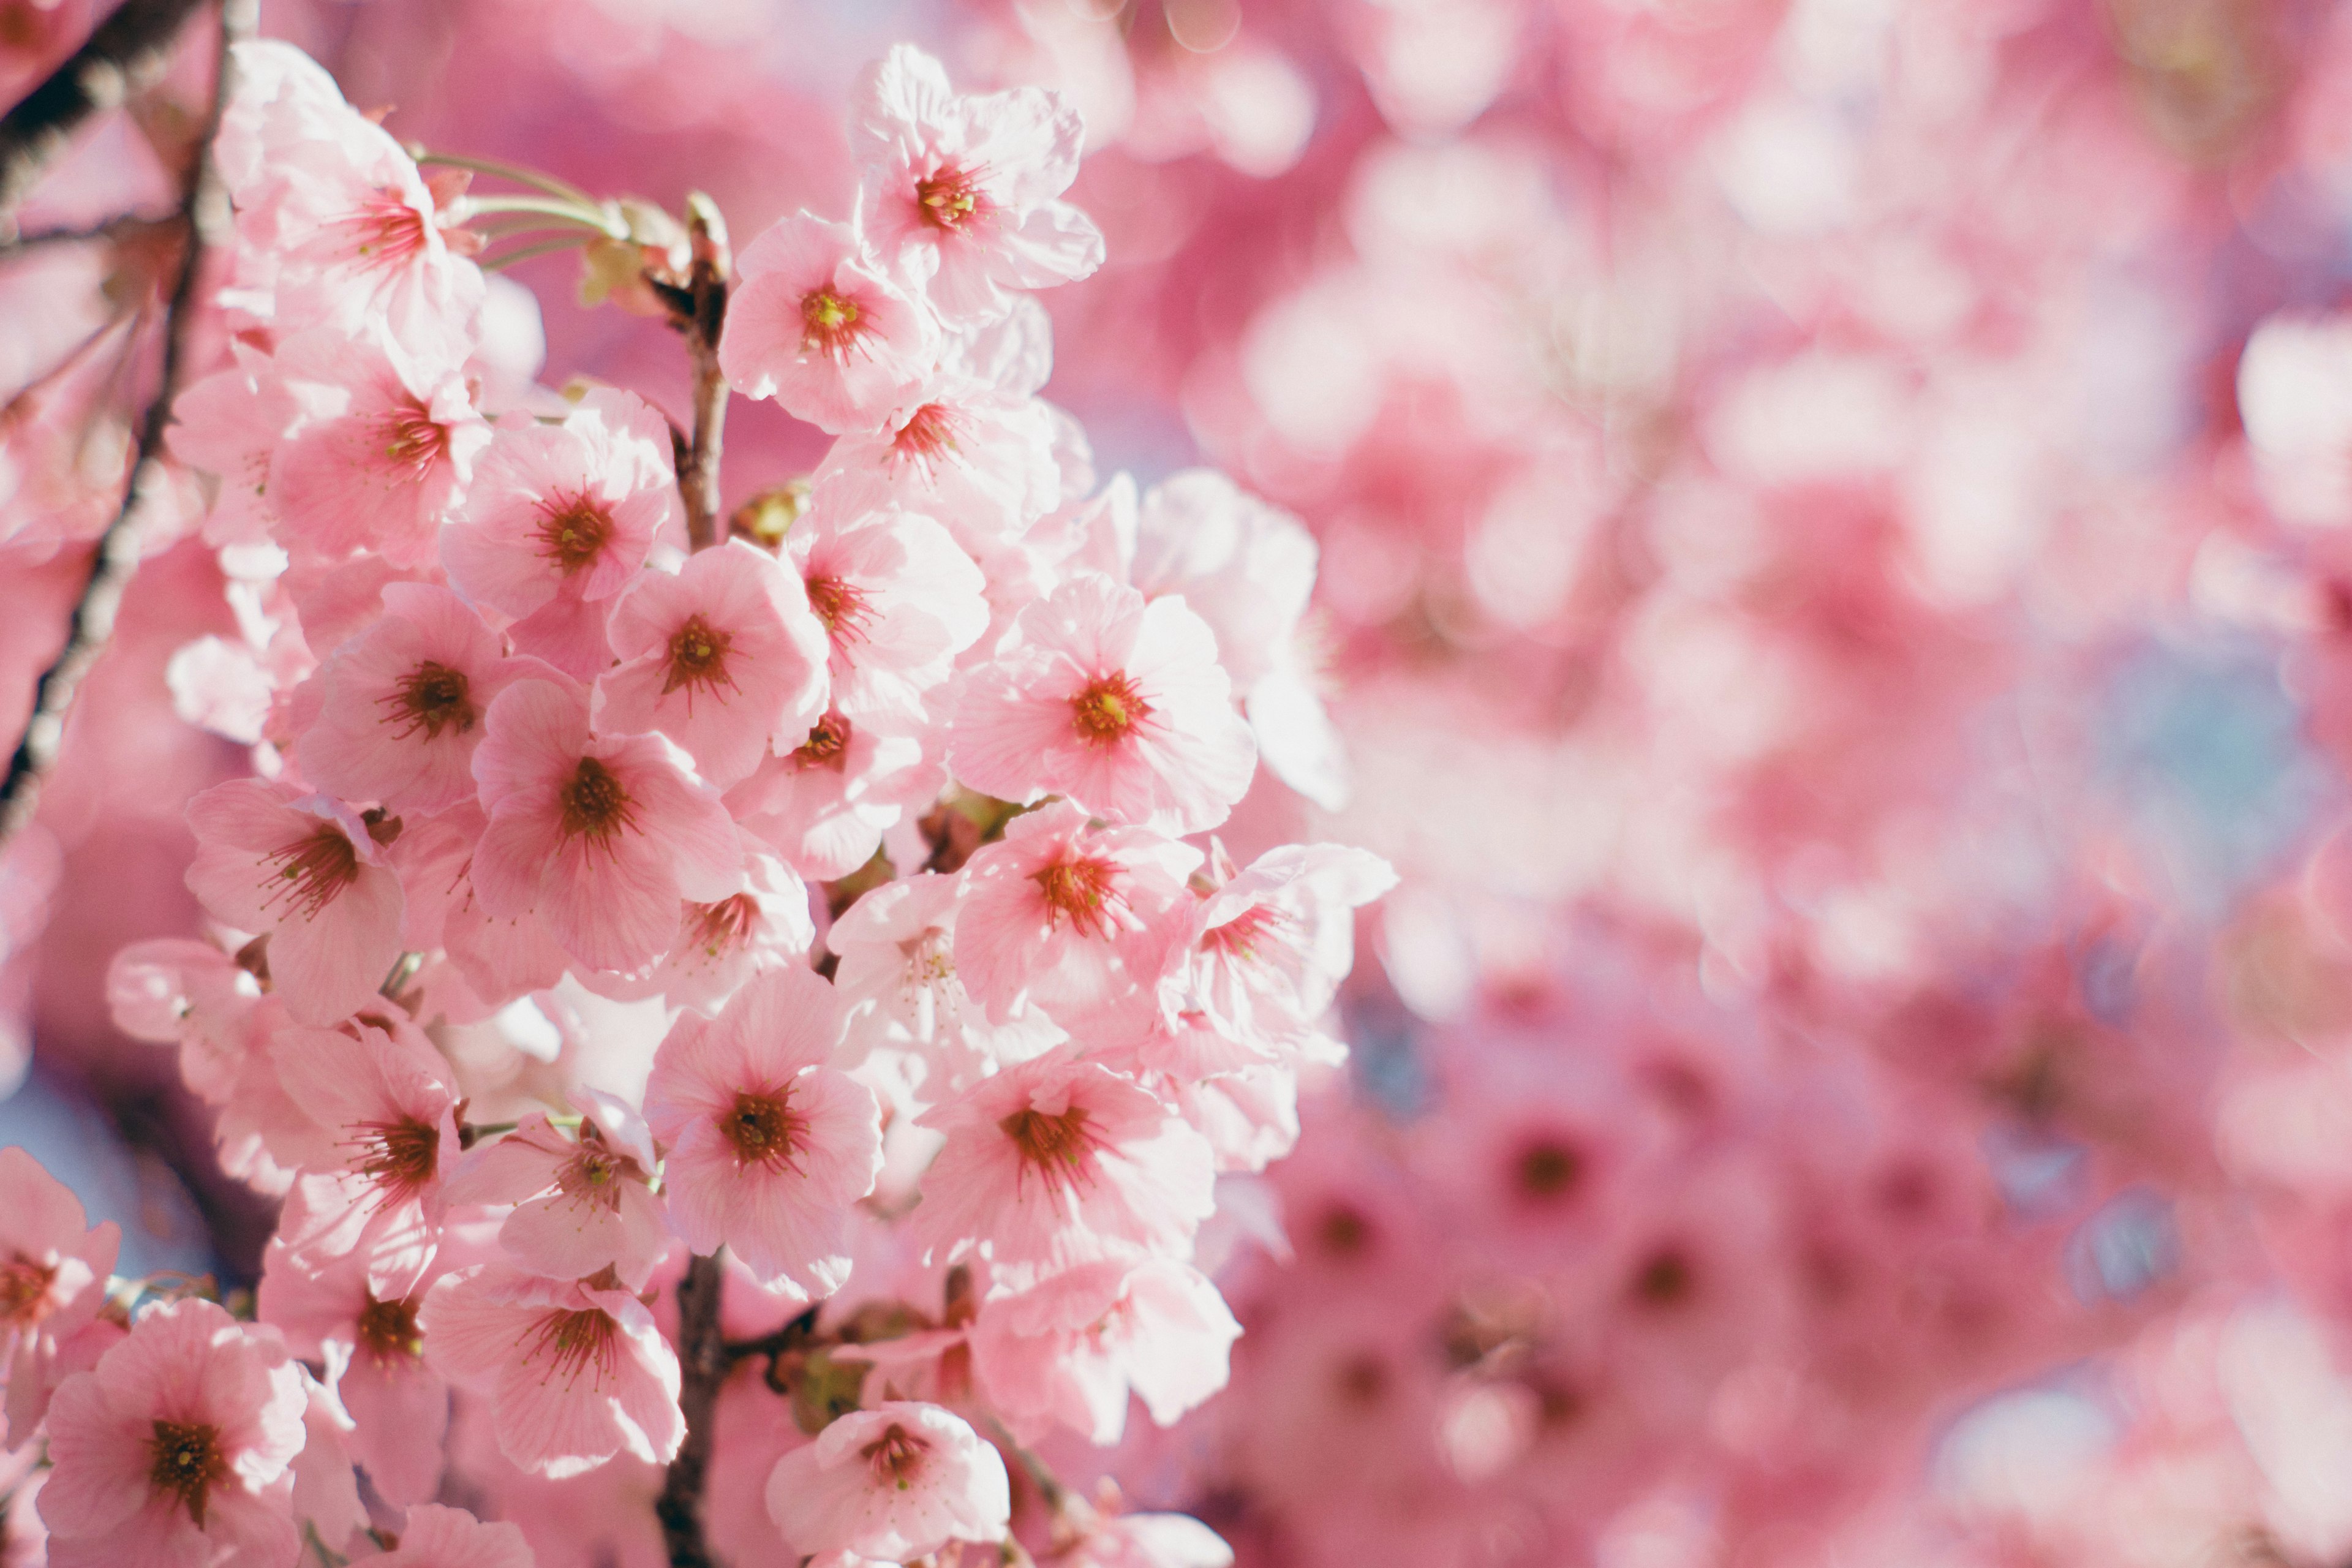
[851,45,1103,320]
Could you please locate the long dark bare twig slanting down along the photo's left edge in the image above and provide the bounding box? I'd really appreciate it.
[0,0,257,844]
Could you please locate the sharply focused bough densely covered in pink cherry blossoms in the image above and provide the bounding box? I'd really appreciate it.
[0,12,1390,1568]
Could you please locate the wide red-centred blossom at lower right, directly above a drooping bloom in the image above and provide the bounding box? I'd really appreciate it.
[913,1044,1216,1272]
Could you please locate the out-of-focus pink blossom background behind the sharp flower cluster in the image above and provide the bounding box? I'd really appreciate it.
[23,0,2352,1568]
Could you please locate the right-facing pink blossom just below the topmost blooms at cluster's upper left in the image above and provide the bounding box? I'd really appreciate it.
[268,326,489,567]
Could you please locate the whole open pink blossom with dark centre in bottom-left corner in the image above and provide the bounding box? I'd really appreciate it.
[40,1300,306,1568]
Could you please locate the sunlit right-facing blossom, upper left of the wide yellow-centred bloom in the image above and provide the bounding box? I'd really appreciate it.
[788,510,988,722]
